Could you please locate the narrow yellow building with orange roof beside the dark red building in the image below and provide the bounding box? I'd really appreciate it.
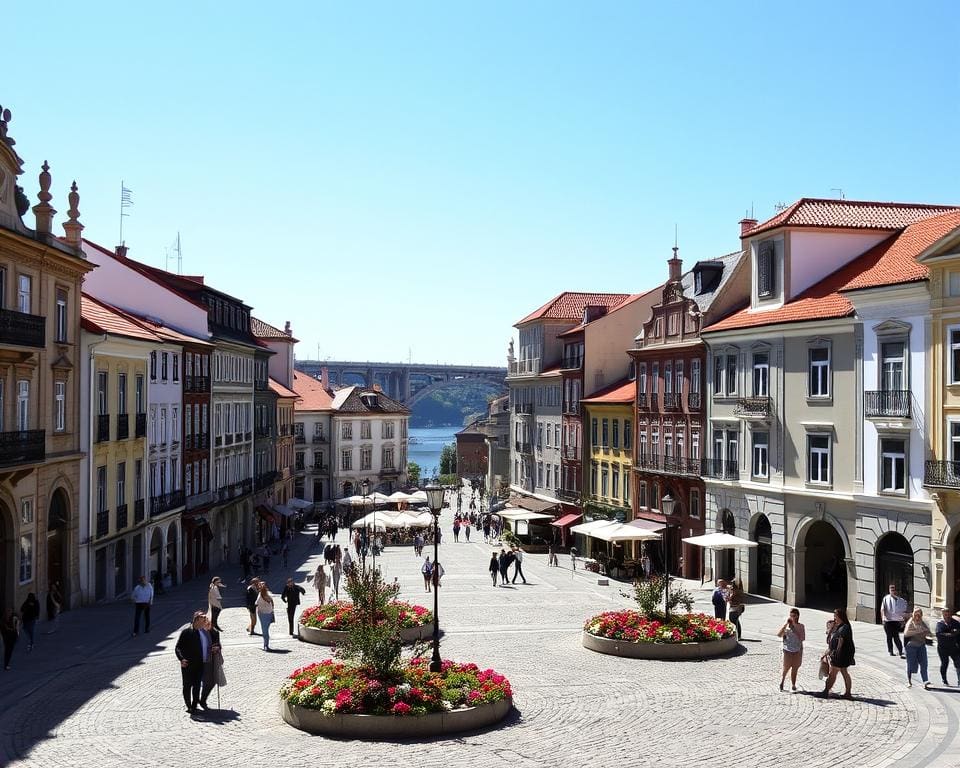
[580,381,637,553]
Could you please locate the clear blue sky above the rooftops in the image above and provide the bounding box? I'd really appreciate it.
[0,0,960,364]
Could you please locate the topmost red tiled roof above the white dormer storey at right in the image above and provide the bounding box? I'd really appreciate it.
[742,197,957,237]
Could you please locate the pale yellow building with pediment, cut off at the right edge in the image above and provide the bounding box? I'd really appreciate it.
[919,211,960,609]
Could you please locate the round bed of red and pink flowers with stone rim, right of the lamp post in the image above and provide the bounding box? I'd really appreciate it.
[583,610,737,659]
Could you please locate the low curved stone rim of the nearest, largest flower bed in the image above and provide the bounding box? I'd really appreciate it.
[280,699,513,741]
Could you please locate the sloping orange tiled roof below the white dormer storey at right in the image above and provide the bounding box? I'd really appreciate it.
[704,210,960,333]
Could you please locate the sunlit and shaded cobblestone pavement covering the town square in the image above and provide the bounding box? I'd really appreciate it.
[0,496,960,768]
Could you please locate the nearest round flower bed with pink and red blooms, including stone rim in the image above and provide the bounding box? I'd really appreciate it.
[280,657,513,738]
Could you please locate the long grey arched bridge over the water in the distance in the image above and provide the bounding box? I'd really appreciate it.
[296,360,507,408]
